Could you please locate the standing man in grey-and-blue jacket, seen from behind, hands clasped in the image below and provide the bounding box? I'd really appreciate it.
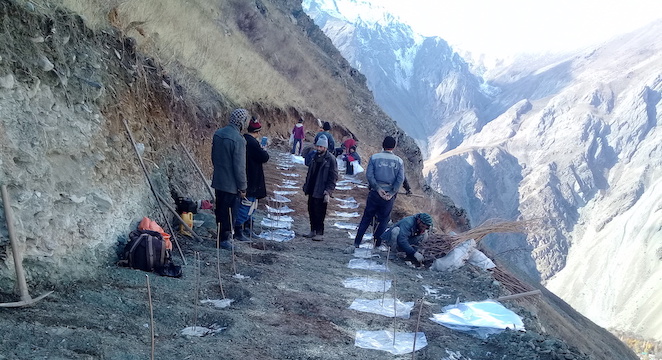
[354,136,405,248]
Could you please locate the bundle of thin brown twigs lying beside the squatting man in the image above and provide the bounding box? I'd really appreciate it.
[421,219,536,259]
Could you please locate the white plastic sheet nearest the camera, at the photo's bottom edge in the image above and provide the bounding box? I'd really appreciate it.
[354,330,428,355]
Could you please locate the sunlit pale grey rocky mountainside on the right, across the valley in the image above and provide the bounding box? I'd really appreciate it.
[425,22,662,340]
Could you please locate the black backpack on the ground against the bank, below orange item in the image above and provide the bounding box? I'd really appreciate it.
[120,230,170,271]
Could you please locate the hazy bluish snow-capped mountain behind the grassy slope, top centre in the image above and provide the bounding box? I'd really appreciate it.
[303,0,488,154]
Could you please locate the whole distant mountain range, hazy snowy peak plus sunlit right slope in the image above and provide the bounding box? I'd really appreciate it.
[304,0,662,340]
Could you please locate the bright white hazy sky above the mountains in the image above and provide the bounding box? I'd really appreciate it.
[372,0,662,56]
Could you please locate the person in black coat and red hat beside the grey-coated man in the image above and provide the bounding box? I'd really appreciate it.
[234,117,269,241]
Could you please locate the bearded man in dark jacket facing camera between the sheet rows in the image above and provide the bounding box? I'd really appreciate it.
[303,136,338,241]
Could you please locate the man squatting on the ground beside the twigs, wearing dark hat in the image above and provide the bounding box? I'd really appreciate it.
[382,213,432,263]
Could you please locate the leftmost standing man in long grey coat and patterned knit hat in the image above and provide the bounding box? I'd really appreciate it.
[211,109,250,250]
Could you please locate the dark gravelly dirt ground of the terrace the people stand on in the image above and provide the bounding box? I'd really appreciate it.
[0,150,636,360]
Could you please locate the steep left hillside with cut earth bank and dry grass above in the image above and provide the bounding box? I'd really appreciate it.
[0,1,464,288]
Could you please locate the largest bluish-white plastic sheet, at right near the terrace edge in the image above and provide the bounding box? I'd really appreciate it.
[430,300,525,339]
